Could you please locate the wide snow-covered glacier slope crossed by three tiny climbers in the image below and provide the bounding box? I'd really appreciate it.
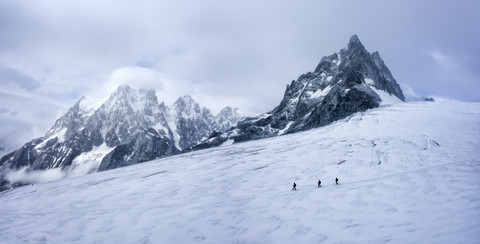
[0,102,480,243]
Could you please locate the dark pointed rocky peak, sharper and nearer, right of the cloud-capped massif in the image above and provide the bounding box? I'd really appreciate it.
[195,35,405,149]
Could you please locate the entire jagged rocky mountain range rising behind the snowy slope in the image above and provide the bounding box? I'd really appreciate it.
[0,35,405,189]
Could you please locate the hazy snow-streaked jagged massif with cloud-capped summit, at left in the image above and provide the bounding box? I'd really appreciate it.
[0,86,240,189]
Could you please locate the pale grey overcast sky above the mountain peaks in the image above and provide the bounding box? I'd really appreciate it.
[0,0,480,153]
